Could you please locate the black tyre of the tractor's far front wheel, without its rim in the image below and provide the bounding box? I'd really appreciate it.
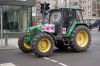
[18,35,32,53]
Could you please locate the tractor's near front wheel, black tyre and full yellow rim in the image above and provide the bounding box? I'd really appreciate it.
[32,33,54,57]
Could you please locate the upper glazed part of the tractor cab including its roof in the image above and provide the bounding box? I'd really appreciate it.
[49,8,83,26]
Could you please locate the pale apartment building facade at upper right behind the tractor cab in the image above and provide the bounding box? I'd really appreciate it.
[70,0,100,22]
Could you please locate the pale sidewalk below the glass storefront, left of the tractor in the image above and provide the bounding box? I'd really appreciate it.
[0,38,18,50]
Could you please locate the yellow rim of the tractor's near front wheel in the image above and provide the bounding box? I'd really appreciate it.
[38,38,51,52]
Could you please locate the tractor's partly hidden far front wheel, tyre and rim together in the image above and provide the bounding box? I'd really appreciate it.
[18,35,32,53]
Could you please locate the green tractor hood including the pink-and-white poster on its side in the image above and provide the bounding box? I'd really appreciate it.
[26,24,55,35]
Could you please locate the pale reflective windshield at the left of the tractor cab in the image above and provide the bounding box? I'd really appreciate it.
[49,12,61,23]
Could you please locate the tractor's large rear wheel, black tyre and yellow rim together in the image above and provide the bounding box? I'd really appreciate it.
[70,25,91,52]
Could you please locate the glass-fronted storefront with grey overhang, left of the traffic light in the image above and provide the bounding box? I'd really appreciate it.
[0,0,36,46]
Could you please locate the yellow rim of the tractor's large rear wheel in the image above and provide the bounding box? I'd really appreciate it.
[76,30,89,47]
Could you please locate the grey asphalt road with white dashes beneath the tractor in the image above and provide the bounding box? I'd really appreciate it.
[0,32,100,66]
